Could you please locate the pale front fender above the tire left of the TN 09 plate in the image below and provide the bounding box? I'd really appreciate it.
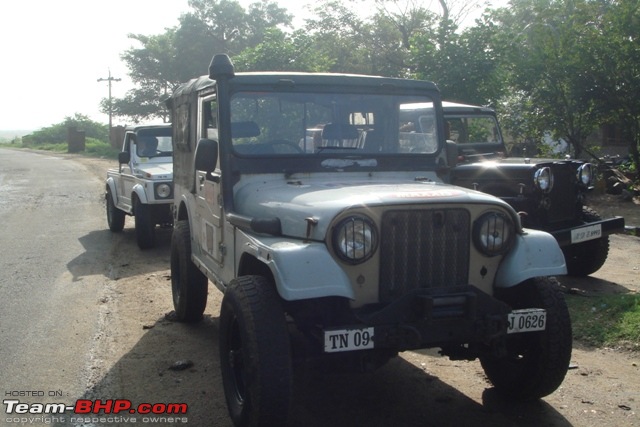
[238,236,355,301]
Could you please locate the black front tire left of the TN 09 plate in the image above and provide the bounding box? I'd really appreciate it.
[220,276,293,427]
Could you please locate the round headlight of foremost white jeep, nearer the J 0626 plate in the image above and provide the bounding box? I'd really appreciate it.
[473,212,514,256]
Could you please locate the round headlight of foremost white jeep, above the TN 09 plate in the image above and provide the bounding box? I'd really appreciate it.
[333,215,378,264]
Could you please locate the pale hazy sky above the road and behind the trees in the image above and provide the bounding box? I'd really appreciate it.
[0,0,490,131]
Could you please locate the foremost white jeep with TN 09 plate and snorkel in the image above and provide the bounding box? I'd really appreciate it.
[167,55,572,426]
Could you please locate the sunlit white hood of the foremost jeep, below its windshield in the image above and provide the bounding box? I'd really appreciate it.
[235,179,509,240]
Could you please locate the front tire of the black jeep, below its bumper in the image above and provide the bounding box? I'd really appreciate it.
[562,206,609,277]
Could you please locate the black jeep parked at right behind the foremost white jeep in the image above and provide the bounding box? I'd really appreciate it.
[402,102,624,276]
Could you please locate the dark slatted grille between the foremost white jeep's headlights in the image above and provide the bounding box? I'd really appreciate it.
[380,209,471,302]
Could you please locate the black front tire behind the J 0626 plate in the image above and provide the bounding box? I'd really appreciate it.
[480,277,572,401]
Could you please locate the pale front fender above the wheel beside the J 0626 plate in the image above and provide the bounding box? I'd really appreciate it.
[495,229,567,288]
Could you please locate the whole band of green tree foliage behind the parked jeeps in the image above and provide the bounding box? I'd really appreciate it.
[94,0,640,164]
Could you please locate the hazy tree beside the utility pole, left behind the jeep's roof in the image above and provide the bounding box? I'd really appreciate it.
[106,0,291,122]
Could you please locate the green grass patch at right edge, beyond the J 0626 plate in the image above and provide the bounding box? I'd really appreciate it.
[566,293,640,351]
